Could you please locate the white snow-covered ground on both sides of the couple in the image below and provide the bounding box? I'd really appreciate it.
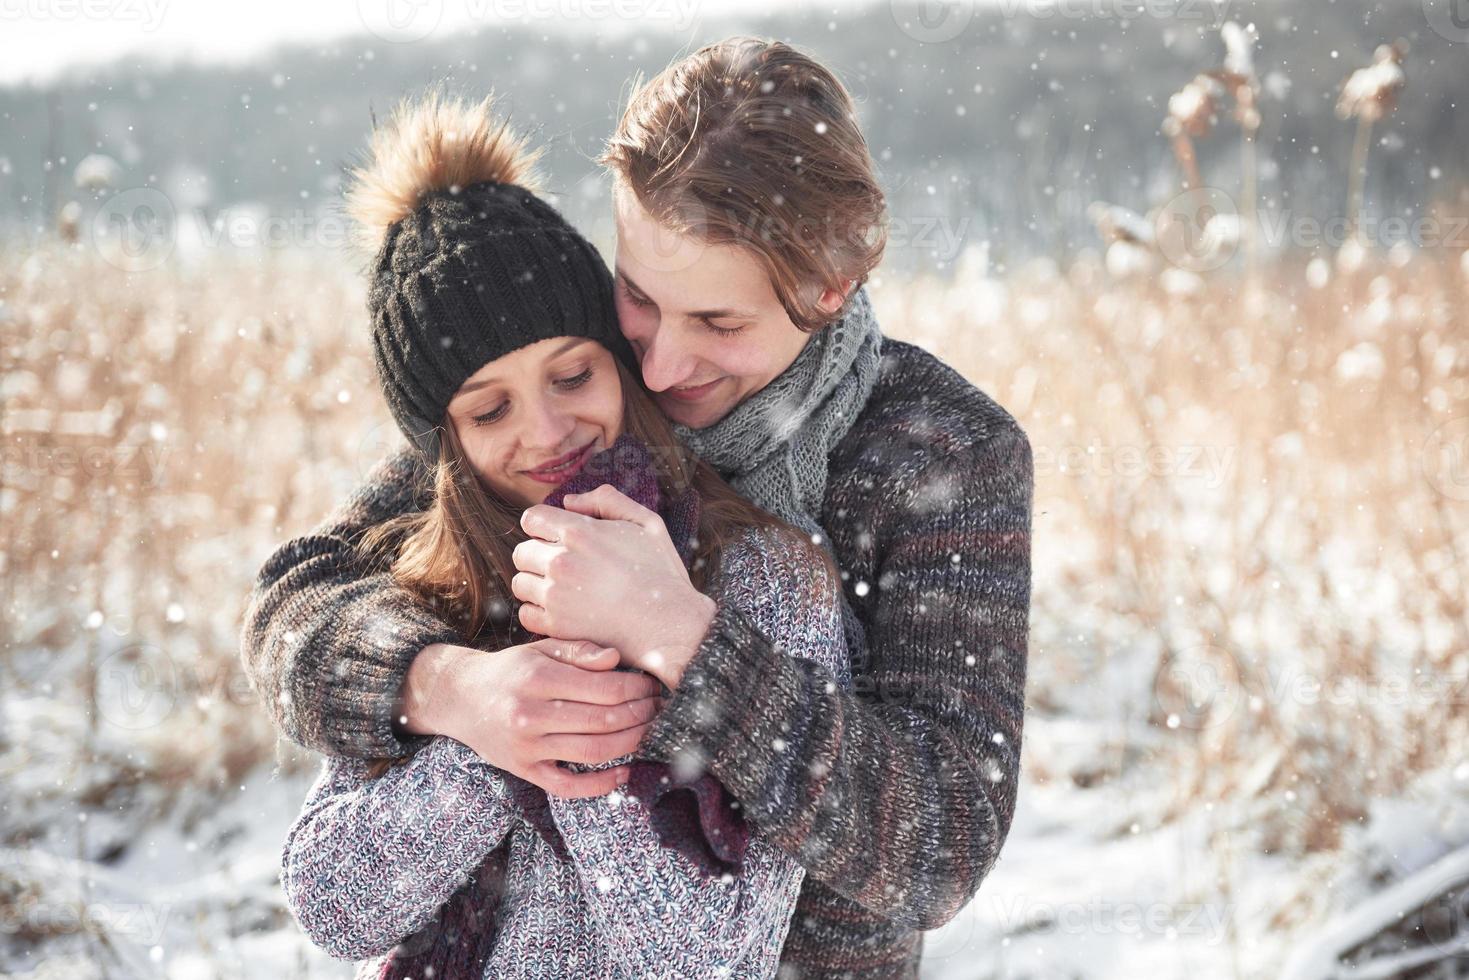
[11,699,1469,980]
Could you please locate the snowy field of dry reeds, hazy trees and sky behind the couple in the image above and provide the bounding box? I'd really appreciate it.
[0,0,1469,980]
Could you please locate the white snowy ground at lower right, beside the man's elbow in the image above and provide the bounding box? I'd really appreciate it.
[924,720,1469,980]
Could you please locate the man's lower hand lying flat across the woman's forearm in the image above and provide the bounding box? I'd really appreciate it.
[400,639,660,798]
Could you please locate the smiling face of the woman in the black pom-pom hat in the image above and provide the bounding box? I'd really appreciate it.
[448,336,623,507]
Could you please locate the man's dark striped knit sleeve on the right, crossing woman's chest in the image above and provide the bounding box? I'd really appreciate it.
[639,420,1033,929]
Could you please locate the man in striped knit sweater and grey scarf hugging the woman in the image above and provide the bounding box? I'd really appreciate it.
[242,38,1033,977]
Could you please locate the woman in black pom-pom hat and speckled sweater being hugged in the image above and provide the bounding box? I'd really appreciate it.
[281,97,846,980]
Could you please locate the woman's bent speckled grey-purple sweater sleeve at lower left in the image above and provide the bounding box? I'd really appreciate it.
[281,736,519,959]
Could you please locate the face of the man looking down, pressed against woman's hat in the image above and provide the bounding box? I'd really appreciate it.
[614,182,843,429]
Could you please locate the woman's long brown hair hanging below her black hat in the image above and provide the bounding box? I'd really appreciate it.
[357,357,837,779]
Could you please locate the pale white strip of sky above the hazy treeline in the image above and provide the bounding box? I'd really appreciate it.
[0,0,816,82]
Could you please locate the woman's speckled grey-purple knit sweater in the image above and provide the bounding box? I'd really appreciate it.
[281,530,849,980]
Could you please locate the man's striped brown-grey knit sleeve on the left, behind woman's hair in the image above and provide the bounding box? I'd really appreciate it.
[241,444,463,758]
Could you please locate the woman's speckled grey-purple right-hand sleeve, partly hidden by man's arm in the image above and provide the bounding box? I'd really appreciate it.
[551,530,848,977]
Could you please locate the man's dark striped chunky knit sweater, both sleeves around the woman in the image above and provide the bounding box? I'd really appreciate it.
[242,338,1034,980]
